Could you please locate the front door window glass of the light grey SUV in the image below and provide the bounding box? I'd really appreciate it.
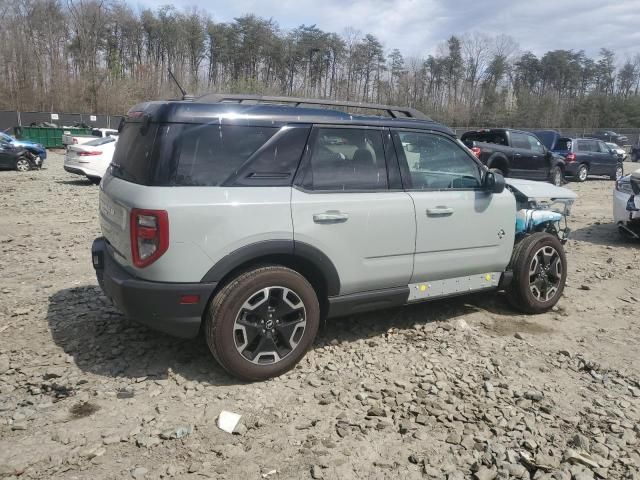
[394,132,480,190]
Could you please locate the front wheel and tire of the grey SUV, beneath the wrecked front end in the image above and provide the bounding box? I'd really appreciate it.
[507,232,567,314]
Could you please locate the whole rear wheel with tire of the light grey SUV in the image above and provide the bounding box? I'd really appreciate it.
[204,266,320,381]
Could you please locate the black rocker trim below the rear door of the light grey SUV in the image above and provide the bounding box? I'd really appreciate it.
[327,286,409,317]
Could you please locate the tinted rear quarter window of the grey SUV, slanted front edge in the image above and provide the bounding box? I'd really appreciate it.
[171,125,278,187]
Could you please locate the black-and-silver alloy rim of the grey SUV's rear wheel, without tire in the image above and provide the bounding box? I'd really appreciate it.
[233,286,307,365]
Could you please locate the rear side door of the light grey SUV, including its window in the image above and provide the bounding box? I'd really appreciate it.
[291,126,416,295]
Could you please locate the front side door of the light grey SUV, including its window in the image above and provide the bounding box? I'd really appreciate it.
[393,130,516,283]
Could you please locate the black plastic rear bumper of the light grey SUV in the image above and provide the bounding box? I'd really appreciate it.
[91,237,217,338]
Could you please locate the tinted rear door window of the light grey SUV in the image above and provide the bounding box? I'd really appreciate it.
[304,128,388,190]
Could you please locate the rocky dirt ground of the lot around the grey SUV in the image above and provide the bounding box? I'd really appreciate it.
[0,154,640,480]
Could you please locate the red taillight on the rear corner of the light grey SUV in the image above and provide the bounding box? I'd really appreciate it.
[131,208,169,268]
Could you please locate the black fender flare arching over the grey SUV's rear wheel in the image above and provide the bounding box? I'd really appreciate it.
[200,240,340,296]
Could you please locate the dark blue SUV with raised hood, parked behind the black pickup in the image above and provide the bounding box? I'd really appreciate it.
[533,130,623,182]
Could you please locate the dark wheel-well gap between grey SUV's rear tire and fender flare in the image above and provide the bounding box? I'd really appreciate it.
[210,254,329,318]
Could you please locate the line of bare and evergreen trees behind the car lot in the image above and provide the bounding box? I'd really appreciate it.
[0,0,640,128]
